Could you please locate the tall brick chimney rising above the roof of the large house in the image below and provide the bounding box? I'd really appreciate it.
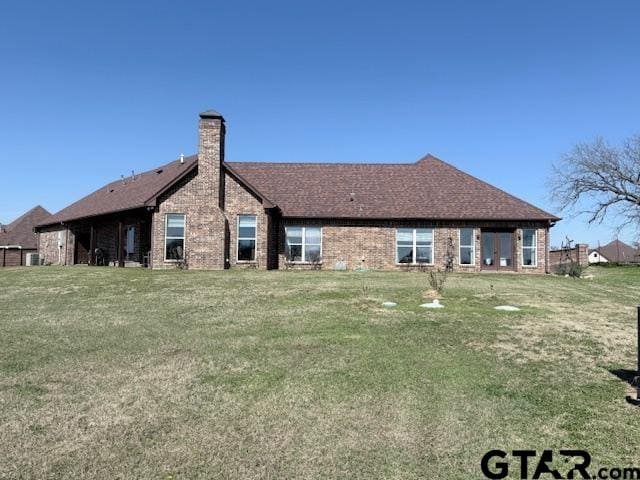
[198,110,225,208]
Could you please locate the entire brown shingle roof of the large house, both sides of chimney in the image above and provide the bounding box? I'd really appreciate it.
[41,155,558,226]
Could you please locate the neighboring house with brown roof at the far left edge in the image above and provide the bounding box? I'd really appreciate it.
[0,205,51,267]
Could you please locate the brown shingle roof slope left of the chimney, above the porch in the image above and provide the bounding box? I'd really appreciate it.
[40,155,198,226]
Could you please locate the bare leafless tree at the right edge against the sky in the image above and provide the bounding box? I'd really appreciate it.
[549,135,640,229]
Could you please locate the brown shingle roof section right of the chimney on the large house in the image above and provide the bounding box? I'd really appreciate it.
[229,155,559,221]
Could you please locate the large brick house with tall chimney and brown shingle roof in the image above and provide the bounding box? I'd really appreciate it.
[38,111,559,273]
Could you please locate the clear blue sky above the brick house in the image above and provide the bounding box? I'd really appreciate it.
[0,0,640,248]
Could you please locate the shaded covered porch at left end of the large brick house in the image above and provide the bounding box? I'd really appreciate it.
[67,208,152,267]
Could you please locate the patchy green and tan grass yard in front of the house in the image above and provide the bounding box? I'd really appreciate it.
[0,267,640,480]
